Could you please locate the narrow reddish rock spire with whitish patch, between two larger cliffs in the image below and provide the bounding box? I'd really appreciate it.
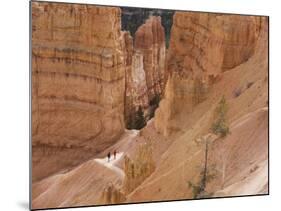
[124,16,166,129]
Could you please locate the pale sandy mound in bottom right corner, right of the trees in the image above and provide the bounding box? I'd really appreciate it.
[207,108,268,196]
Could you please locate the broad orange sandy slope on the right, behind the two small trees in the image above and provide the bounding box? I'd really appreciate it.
[128,24,268,202]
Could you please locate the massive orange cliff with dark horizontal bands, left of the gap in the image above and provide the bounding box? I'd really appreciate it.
[32,2,125,178]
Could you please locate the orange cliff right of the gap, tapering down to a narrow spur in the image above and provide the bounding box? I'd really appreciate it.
[155,12,262,135]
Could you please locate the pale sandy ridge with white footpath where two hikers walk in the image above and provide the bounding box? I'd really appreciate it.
[32,131,138,208]
